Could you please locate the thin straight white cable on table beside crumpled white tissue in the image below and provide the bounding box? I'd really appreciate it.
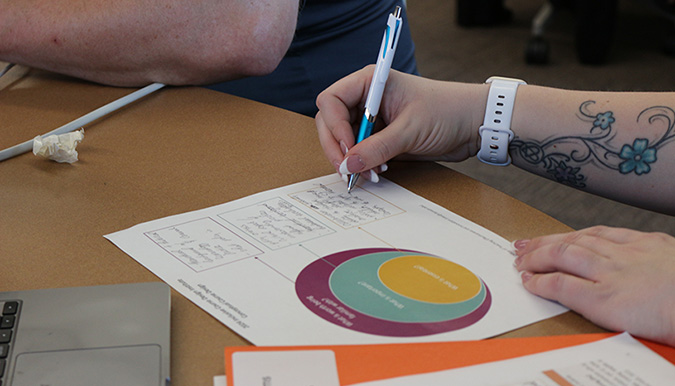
[0,83,164,162]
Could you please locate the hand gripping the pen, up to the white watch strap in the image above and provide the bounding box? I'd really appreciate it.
[316,66,487,178]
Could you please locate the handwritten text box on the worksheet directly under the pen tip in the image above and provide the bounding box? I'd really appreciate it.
[290,184,403,229]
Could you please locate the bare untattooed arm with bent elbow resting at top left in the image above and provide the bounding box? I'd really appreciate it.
[0,0,298,86]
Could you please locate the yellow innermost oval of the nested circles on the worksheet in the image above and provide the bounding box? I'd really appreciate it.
[378,255,481,304]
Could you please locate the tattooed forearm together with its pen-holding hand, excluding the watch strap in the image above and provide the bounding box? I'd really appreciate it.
[317,68,675,214]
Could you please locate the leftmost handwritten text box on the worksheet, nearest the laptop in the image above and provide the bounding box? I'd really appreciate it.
[144,218,262,272]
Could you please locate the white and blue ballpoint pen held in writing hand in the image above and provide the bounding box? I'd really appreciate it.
[347,6,403,193]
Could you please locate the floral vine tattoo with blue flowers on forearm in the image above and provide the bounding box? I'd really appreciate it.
[509,101,675,188]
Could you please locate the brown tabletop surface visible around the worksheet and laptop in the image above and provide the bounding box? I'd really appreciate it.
[0,68,603,386]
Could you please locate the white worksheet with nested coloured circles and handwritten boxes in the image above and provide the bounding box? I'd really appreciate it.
[105,175,566,346]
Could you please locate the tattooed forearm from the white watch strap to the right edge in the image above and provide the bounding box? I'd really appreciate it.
[510,86,675,214]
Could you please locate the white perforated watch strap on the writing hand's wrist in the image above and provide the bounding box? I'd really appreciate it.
[478,76,526,166]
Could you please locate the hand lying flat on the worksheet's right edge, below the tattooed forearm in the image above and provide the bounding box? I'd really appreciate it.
[515,227,675,346]
